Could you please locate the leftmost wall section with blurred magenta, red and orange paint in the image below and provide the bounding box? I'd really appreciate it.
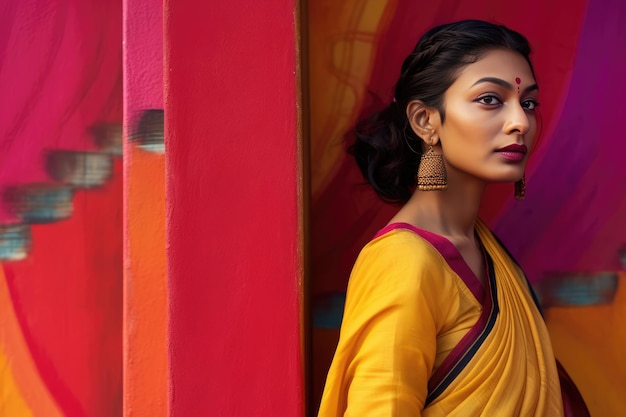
[0,0,122,417]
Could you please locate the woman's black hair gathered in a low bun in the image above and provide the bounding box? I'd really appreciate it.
[348,20,534,203]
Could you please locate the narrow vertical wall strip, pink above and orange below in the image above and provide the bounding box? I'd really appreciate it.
[124,0,167,417]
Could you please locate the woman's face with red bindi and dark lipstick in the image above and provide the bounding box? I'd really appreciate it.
[436,49,537,182]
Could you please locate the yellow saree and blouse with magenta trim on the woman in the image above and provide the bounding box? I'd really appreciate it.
[319,222,563,417]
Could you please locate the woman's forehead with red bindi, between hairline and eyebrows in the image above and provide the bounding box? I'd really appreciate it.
[450,49,535,88]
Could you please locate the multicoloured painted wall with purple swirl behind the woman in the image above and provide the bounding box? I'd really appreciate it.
[309,0,626,415]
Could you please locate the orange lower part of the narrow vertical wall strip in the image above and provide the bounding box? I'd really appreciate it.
[124,147,167,417]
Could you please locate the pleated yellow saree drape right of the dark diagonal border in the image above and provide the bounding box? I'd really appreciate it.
[423,219,563,416]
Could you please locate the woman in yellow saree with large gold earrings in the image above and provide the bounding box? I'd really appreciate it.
[319,21,584,417]
